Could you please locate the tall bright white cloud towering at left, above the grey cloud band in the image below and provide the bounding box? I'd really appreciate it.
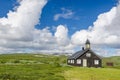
[0,0,46,40]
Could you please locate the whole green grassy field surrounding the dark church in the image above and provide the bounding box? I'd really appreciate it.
[0,54,120,80]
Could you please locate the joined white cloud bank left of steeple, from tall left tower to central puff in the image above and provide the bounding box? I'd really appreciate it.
[0,0,72,53]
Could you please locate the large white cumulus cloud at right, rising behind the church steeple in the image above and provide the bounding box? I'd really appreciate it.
[71,5,120,47]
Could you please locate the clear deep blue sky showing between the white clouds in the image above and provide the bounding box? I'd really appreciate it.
[0,0,117,35]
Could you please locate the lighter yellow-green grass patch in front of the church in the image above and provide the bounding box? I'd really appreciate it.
[64,67,120,80]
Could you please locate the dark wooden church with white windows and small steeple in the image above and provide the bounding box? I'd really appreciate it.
[67,39,102,67]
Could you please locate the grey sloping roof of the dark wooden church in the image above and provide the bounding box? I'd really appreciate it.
[68,49,101,59]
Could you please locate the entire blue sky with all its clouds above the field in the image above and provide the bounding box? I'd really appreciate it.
[0,0,120,56]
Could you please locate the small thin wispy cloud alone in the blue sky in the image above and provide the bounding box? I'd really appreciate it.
[54,8,74,21]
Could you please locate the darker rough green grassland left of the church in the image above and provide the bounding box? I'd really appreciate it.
[0,54,65,80]
